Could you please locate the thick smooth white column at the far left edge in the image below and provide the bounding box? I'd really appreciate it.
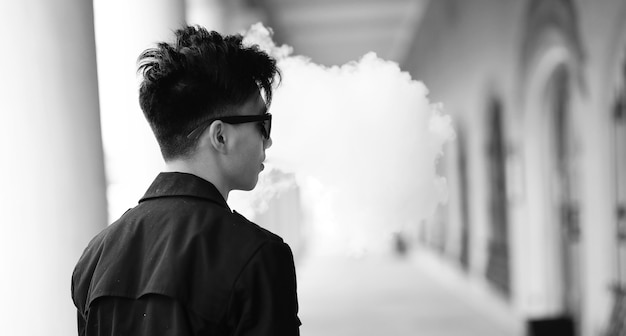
[0,0,106,336]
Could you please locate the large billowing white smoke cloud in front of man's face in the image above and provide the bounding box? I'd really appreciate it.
[230,24,454,255]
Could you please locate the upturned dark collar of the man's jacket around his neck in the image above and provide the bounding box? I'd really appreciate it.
[139,172,230,210]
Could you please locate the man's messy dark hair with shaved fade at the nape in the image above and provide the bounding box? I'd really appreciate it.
[138,26,280,160]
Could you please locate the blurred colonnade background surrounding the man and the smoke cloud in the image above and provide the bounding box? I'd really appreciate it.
[0,0,626,336]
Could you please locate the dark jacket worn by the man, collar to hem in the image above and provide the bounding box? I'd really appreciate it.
[72,173,300,336]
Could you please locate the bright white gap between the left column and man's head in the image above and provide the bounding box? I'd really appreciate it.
[94,0,185,220]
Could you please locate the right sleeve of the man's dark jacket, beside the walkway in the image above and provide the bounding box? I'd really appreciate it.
[229,242,301,336]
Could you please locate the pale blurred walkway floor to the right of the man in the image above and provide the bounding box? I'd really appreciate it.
[298,253,519,336]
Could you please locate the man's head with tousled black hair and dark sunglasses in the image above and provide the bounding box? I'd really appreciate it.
[139,27,280,194]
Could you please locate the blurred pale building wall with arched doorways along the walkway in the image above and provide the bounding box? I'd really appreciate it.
[402,0,626,335]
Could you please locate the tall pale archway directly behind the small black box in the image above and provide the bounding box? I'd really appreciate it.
[524,53,581,336]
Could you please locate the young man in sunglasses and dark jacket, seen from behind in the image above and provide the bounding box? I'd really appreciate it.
[72,27,300,336]
